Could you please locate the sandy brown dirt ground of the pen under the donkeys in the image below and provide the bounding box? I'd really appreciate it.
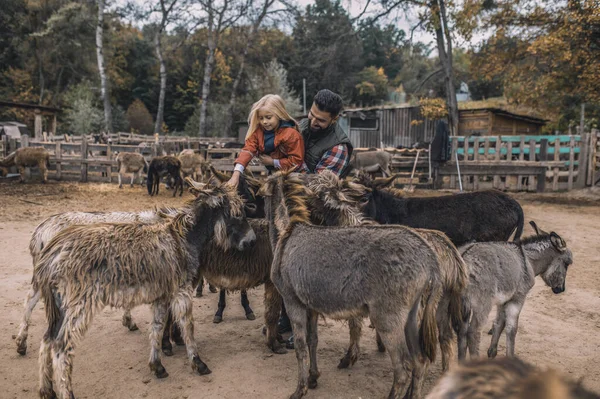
[0,182,600,399]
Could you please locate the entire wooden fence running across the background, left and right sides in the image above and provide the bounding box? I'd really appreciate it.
[0,130,600,191]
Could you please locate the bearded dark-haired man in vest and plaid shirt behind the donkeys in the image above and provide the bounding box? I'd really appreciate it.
[278,89,353,349]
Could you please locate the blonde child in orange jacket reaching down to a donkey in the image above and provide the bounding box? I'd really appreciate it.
[229,94,304,186]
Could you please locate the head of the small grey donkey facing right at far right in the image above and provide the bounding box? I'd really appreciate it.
[529,221,573,294]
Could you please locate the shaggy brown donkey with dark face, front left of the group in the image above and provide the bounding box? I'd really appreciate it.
[35,187,256,398]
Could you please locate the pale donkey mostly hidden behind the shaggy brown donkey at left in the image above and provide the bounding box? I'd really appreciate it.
[16,208,177,355]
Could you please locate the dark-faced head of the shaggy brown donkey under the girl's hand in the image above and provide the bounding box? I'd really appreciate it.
[186,177,256,251]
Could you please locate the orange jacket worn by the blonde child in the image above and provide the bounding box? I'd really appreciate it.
[235,126,304,170]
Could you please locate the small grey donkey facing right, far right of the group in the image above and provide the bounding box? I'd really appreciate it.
[457,222,573,360]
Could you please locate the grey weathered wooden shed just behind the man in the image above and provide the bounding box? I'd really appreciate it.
[340,105,435,147]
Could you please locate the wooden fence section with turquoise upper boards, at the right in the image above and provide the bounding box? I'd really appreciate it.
[438,134,590,191]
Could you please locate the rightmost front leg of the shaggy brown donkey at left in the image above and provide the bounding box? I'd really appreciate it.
[171,291,211,375]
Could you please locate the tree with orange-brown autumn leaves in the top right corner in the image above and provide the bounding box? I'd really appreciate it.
[473,0,600,130]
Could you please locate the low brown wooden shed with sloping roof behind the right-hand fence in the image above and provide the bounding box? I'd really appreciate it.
[458,108,546,136]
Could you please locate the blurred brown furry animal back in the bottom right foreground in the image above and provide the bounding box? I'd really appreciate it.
[426,357,600,399]
